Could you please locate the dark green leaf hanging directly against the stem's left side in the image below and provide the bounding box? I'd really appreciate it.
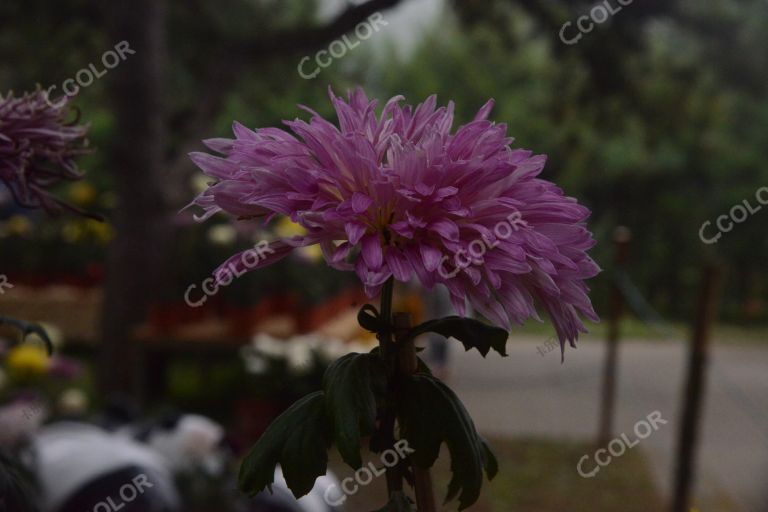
[323,353,386,469]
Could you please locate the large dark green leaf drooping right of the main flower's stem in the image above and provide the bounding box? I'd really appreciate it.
[400,373,498,510]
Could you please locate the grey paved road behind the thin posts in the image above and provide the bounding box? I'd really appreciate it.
[451,337,768,512]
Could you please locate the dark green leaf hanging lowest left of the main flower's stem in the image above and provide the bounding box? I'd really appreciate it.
[239,391,331,498]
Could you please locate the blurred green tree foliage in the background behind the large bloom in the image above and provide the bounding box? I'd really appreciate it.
[0,0,768,322]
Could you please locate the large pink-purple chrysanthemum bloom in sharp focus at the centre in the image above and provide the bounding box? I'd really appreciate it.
[190,89,599,344]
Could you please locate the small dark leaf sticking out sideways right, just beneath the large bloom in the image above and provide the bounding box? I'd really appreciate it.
[410,316,509,357]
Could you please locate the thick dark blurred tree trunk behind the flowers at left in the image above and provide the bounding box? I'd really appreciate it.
[100,0,172,399]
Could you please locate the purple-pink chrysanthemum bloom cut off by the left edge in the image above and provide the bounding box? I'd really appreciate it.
[0,90,88,213]
